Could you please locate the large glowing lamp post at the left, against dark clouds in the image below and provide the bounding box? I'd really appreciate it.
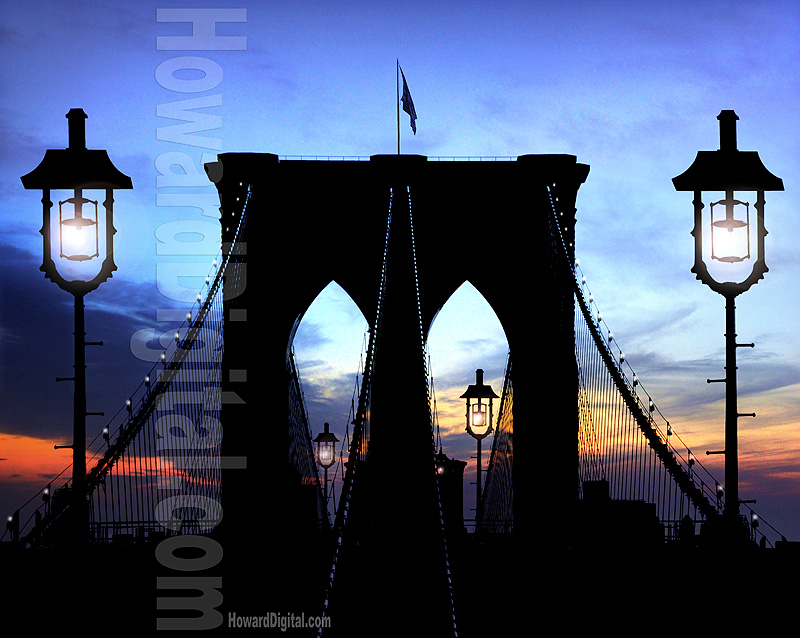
[20,109,133,542]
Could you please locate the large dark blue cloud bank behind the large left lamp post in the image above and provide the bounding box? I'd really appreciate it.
[0,246,164,437]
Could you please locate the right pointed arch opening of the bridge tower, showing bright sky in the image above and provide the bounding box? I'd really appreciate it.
[427,281,509,520]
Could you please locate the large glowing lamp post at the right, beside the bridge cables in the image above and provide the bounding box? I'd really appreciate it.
[672,110,783,530]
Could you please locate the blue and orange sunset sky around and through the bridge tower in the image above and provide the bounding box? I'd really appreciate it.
[0,0,800,540]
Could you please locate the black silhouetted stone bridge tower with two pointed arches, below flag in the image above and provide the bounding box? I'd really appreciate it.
[206,153,589,624]
